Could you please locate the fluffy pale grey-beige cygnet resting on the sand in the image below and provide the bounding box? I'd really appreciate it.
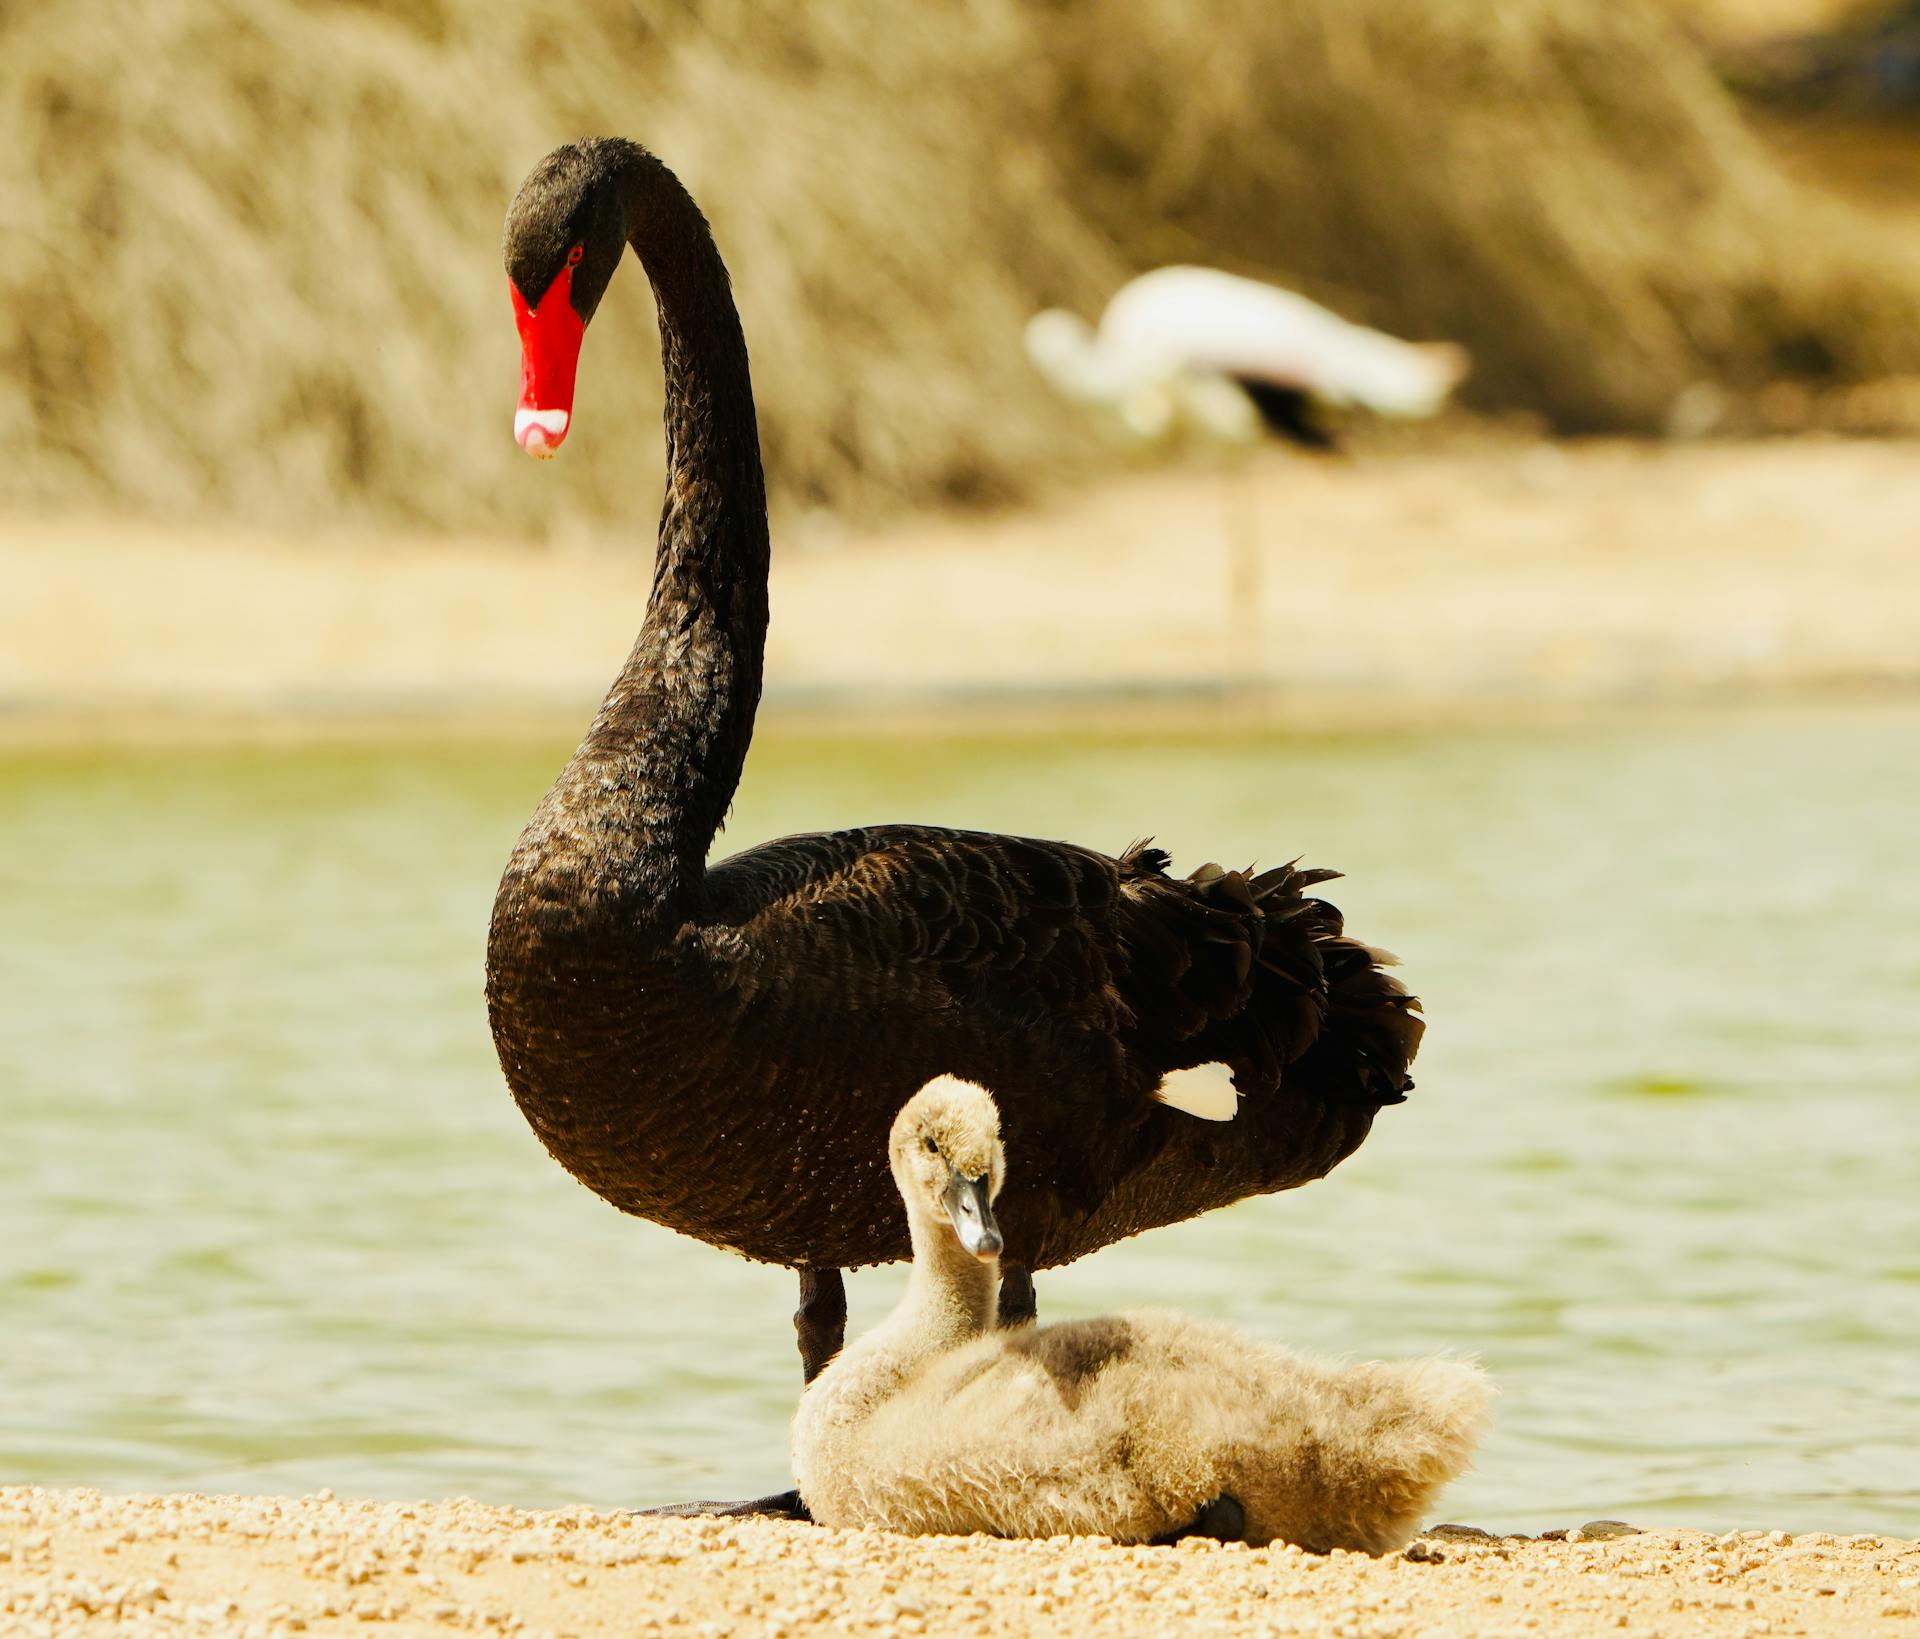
[793,1077,1492,1553]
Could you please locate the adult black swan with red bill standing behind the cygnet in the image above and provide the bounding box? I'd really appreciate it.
[488,140,1421,1378]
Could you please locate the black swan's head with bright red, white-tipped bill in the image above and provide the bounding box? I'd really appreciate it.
[505,140,634,459]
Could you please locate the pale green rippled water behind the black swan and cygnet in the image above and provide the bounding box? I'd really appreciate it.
[0,710,1920,1535]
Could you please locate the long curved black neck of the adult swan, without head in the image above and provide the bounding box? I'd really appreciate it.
[555,150,768,925]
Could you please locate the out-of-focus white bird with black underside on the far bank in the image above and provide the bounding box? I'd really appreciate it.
[1027,267,1469,449]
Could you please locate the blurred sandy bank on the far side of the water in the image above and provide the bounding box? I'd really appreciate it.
[0,439,1920,733]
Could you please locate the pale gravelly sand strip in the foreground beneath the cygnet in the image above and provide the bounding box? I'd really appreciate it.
[0,1487,1920,1639]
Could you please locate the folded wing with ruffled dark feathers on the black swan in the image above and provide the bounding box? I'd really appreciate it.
[708,825,1421,1104]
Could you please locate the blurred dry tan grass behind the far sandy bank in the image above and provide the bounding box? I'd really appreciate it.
[0,0,1920,532]
